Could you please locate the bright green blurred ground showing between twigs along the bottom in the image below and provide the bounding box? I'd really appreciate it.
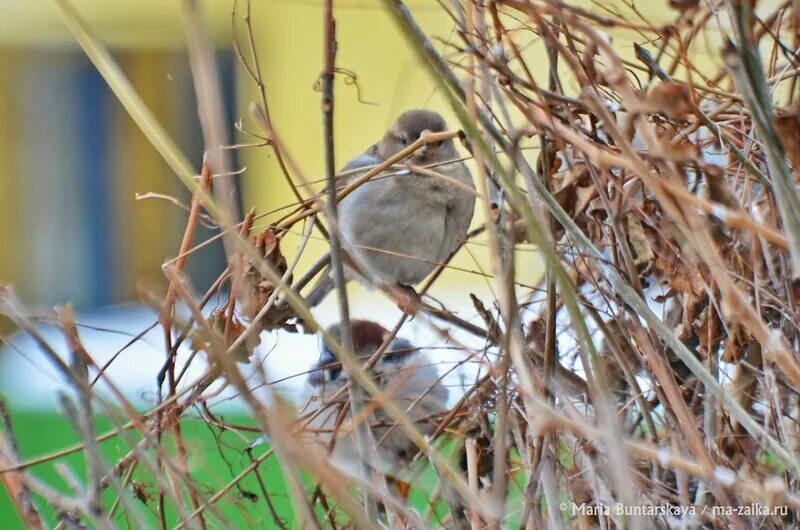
[0,411,540,530]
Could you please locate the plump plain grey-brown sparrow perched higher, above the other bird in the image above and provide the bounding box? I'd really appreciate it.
[307,109,475,307]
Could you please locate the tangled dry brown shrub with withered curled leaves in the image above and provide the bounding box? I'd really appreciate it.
[0,0,800,528]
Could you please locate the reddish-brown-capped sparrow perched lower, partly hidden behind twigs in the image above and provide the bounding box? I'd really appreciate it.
[300,320,448,476]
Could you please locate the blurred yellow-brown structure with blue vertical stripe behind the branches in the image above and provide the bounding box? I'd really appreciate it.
[0,1,235,310]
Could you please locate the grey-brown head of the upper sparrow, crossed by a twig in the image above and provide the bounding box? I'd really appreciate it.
[378,109,456,165]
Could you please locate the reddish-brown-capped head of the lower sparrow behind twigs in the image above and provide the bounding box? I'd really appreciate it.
[309,320,417,385]
